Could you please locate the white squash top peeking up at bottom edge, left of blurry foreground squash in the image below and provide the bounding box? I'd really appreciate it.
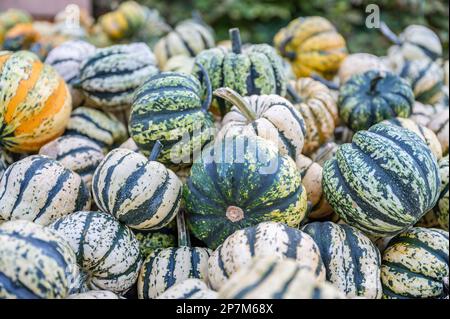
[157,278,217,299]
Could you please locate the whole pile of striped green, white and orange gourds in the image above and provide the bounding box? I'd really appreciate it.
[0,1,449,299]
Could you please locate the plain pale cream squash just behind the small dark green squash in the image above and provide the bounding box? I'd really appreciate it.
[338,53,389,85]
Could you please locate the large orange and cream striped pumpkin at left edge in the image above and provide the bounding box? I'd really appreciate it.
[0,51,72,153]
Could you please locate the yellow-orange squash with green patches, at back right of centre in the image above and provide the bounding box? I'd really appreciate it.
[274,17,347,79]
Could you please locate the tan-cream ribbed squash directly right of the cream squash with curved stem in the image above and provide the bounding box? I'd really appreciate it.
[288,78,339,155]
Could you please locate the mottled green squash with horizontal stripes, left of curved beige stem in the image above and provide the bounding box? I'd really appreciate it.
[129,72,216,166]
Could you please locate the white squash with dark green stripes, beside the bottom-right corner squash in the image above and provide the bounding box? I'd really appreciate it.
[302,222,383,299]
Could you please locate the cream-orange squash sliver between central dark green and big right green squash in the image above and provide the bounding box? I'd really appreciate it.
[295,155,333,219]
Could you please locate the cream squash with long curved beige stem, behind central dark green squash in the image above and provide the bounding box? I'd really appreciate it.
[214,88,306,160]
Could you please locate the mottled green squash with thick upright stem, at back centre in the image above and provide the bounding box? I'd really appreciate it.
[192,29,287,116]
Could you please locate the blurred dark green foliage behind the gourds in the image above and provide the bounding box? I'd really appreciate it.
[104,0,449,57]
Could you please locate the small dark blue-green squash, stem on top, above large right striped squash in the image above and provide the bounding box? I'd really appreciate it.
[338,71,414,131]
